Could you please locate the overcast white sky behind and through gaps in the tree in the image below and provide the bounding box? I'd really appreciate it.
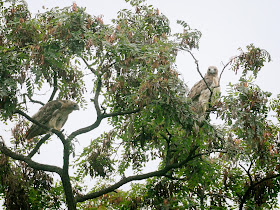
[0,0,280,191]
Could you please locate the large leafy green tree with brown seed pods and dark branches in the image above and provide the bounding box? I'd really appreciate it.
[0,0,280,209]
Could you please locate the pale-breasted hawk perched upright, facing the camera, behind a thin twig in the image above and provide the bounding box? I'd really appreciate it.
[188,66,220,115]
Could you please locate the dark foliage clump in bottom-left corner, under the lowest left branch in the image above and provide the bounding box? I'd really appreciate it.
[0,155,62,209]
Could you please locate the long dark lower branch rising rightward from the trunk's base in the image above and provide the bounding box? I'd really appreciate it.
[76,146,198,202]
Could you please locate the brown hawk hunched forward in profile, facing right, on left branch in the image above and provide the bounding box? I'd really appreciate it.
[26,100,79,140]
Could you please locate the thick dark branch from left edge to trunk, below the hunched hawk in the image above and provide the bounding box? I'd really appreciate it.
[0,142,62,175]
